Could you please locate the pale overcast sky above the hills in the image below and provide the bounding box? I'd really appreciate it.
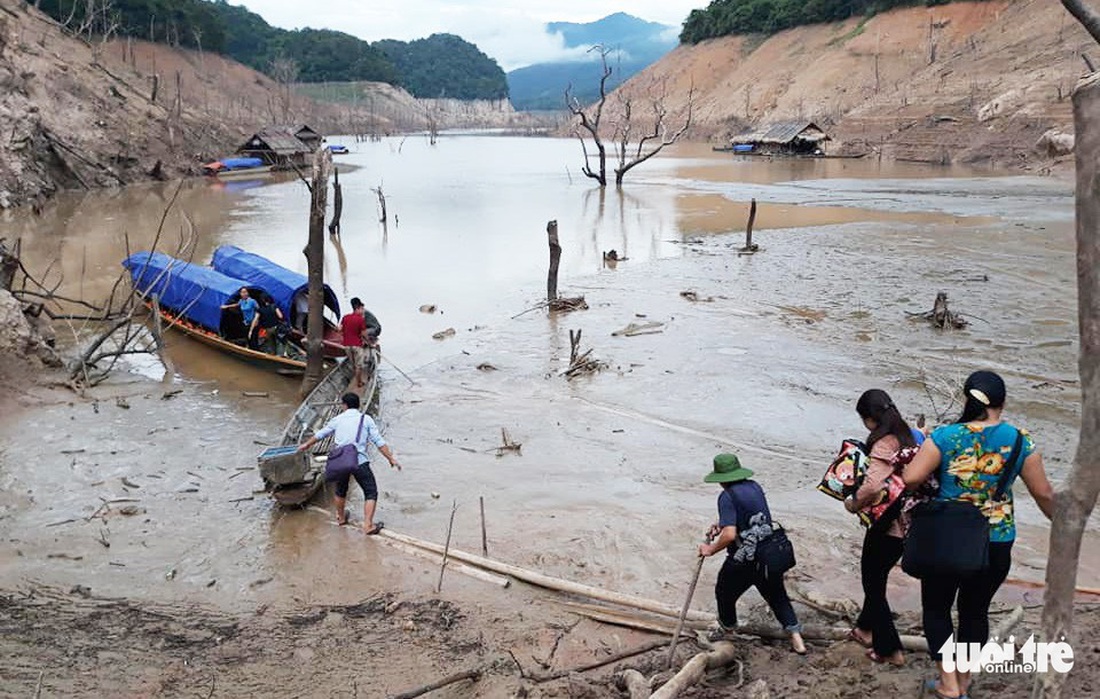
[236,0,710,70]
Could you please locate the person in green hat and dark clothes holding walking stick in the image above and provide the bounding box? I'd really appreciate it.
[699,454,806,655]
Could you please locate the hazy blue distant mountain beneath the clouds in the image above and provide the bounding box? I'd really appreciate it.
[508,12,678,110]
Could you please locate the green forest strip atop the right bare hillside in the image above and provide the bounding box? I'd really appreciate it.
[680,0,972,44]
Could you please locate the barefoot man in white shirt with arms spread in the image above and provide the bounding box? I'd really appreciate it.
[298,393,402,534]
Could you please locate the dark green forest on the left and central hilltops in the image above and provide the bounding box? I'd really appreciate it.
[40,0,508,99]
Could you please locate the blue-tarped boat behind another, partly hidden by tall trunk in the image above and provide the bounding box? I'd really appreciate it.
[210,245,344,359]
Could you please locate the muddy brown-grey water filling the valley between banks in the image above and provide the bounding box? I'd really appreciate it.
[0,136,1100,607]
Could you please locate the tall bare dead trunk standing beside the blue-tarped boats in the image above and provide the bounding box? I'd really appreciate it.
[301,149,332,395]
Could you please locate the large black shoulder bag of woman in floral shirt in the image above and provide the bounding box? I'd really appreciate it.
[901,430,1024,579]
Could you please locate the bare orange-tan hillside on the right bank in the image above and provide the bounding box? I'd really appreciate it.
[622,0,1095,165]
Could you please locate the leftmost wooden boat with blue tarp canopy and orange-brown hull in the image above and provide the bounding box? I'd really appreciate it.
[122,252,332,375]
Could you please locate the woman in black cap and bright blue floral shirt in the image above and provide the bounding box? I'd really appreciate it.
[902,371,1054,698]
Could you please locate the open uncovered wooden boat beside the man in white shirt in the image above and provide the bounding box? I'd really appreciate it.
[257,349,380,506]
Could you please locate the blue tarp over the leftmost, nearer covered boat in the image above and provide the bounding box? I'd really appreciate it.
[122,252,260,332]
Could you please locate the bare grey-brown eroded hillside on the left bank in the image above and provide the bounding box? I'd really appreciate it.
[0,0,242,208]
